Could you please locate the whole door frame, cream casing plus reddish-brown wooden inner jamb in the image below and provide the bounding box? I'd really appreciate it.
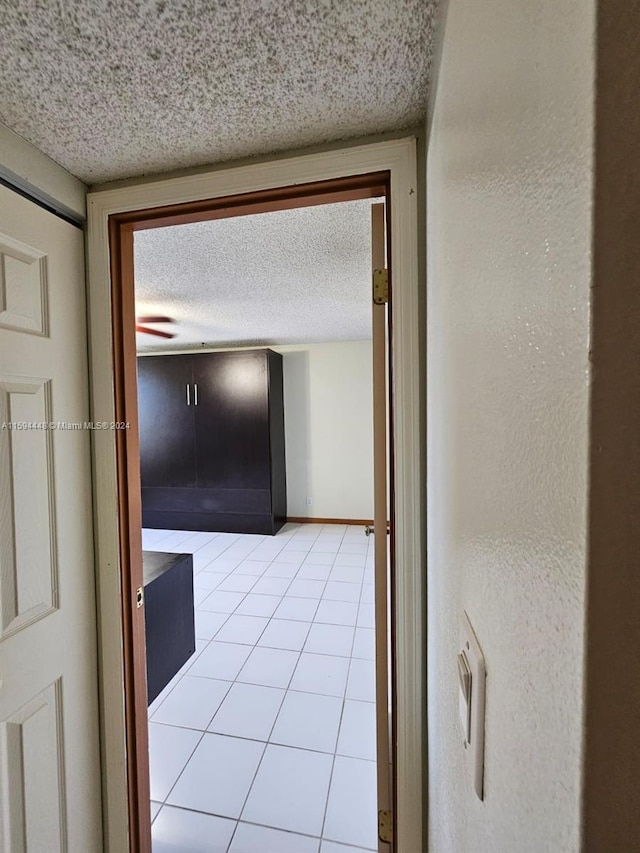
[87,138,426,853]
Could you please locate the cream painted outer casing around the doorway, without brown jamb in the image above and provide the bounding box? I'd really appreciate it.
[87,137,426,853]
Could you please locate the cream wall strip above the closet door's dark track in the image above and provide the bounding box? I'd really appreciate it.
[0,124,87,222]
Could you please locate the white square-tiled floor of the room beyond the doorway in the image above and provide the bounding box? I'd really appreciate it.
[143,524,377,853]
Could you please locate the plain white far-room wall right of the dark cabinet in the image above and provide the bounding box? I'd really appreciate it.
[272,341,373,519]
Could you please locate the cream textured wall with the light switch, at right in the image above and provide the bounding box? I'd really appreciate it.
[427,0,604,853]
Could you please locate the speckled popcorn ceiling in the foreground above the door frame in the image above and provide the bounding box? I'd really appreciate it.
[0,0,436,184]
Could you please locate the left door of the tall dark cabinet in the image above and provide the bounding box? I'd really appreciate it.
[138,355,196,488]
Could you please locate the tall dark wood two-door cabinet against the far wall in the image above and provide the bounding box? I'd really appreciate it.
[138,349,286,533]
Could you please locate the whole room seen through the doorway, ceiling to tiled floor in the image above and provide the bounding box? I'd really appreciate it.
[134,199,378,853]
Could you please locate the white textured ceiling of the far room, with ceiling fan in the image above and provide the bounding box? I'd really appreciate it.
[134,200,378,352]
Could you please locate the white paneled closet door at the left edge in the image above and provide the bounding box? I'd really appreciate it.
[0,186,102,853]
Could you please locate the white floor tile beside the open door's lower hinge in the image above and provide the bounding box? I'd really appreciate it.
[323,755,378,849]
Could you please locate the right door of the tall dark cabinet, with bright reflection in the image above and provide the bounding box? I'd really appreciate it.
[193,351,270,489]
